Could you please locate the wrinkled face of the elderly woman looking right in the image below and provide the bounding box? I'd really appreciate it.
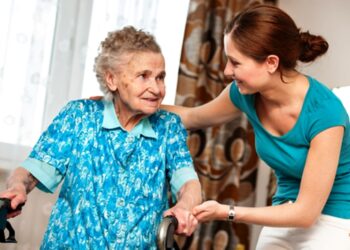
[109,52,165,115]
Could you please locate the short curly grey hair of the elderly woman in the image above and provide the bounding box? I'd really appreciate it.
[94,26,161,100]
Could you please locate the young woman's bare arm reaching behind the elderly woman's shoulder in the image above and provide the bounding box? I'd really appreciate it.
[161,85,240,129]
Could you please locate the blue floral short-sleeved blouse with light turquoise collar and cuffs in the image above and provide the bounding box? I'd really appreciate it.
[22,100,198,250]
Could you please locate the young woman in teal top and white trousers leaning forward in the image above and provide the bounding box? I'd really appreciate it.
[165,5,350,250]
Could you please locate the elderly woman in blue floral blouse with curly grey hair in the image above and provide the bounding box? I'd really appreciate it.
[0,27,201,249]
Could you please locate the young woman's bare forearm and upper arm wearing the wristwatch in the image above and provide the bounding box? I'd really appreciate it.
[193,126,344,228]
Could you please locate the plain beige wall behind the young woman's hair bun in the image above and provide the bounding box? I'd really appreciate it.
[278,0,350,87]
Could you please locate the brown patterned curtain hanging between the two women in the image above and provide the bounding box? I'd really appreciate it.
[175,0,258,250]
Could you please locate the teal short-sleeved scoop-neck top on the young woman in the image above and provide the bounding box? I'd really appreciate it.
[230,76,350,219]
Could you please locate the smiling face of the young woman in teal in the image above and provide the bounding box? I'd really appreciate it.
[224,34,270,94]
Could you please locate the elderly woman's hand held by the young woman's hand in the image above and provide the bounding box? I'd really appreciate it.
[164,204,198,236]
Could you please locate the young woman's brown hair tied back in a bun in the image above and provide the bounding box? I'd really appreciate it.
[224,5,328,74]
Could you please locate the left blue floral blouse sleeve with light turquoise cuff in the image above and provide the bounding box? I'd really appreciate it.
[21,101,81,192]
